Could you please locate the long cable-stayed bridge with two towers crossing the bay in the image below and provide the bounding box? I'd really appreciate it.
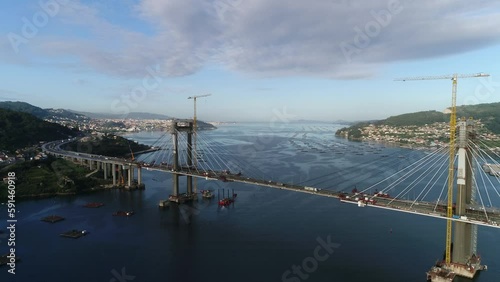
[44,118,500,281]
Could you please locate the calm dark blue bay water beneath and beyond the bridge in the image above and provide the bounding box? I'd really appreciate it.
[0,124,500,282]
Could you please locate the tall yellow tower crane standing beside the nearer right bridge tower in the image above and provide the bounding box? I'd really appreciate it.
[395,73,490,265]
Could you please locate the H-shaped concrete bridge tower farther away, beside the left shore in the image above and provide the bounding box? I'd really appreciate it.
[169,120,196,203]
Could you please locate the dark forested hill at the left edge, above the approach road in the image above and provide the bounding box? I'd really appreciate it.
[0,109,78,151]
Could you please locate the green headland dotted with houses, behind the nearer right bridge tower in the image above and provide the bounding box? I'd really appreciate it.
[336,103,500,147]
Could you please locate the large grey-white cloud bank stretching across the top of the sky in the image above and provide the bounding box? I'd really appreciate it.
[0,0,500,79]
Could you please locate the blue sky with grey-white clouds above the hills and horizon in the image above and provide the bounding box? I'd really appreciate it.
[0,0,500,121]
